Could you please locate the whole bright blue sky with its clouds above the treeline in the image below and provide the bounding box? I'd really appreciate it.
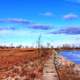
[0,0,80,46]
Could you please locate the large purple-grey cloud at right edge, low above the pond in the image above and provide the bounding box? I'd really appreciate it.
[50,27,80,35]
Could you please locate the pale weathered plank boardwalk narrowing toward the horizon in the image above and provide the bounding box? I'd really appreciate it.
[43,50,59,80]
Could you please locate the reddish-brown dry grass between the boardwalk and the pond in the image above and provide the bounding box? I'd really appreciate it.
[57,56,80,80]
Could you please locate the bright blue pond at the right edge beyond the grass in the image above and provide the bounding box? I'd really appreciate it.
[59,50,80,64]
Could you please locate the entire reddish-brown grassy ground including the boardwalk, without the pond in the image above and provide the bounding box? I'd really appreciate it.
[0,48,80,80]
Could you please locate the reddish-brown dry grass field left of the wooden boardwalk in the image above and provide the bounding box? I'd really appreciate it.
[0,48,49,80]
